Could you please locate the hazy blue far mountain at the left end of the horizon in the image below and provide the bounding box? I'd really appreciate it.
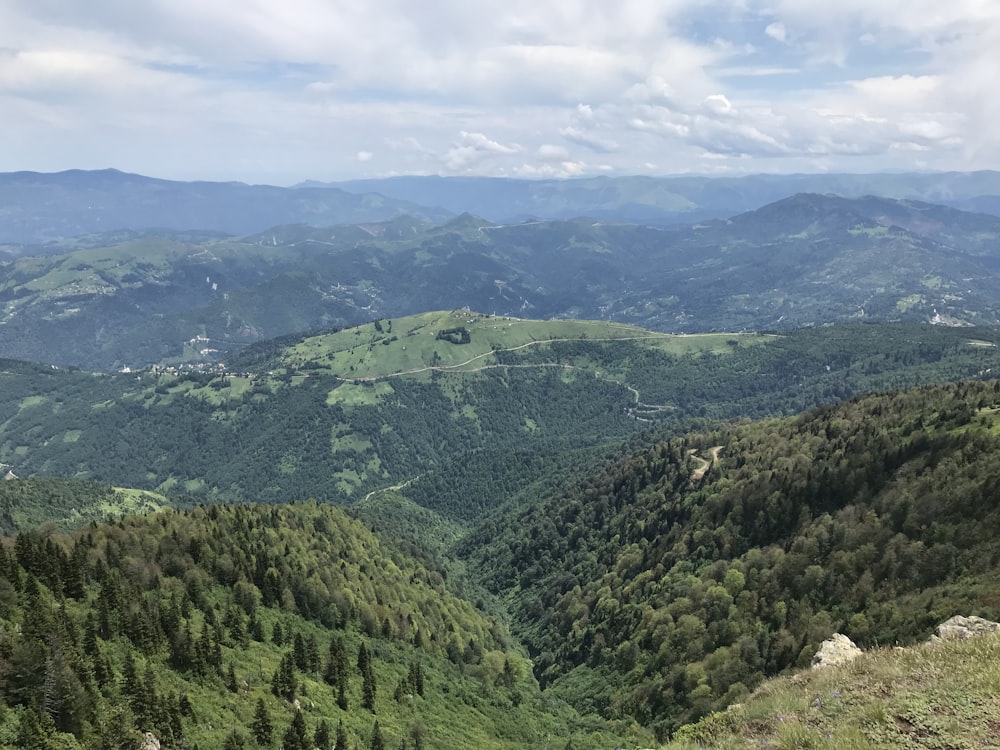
[0,169,448,245]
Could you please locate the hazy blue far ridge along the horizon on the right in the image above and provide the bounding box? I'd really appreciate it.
[324,171,1000,226]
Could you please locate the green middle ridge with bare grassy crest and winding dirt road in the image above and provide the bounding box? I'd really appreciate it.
[0,311,1000,522]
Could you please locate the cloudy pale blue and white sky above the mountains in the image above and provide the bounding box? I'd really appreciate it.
[0,0,1000,185]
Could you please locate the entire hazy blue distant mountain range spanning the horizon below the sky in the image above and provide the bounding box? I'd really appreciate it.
[0,169,1000,245]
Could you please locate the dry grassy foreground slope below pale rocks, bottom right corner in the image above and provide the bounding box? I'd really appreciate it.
[666,635,1000,750]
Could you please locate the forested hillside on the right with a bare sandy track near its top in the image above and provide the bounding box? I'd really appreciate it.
[462,383,1000,736]
